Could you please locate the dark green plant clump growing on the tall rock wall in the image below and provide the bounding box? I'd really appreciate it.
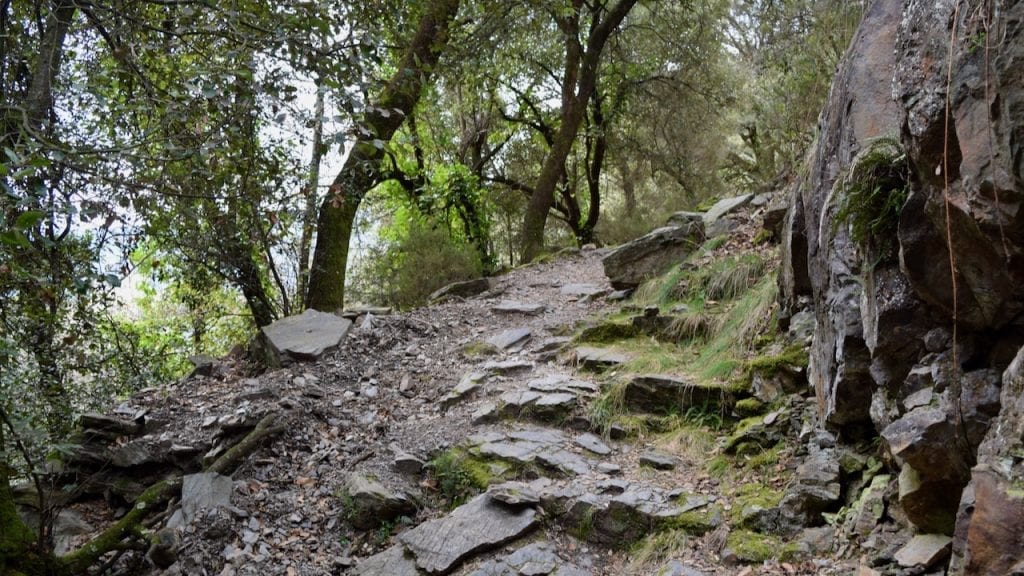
[833,137,910,259]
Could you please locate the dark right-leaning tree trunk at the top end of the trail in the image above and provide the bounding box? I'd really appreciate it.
[522,0,637,261]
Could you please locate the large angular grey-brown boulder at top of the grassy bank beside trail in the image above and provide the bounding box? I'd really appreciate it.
[601,220,703,289]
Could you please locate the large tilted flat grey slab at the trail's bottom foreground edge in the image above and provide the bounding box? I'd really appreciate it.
[398,494,538,574]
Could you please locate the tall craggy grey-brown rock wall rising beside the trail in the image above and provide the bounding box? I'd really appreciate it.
[779,0,1024,574]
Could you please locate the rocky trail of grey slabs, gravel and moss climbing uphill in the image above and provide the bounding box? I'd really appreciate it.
[25,191,909,576]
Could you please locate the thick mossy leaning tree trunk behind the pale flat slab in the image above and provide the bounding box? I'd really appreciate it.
[306,0,460,312]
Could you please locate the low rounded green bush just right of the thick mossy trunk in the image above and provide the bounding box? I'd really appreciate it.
[349,214,483,310]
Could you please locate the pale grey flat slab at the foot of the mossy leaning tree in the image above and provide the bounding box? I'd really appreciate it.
[260,310,352,366]
